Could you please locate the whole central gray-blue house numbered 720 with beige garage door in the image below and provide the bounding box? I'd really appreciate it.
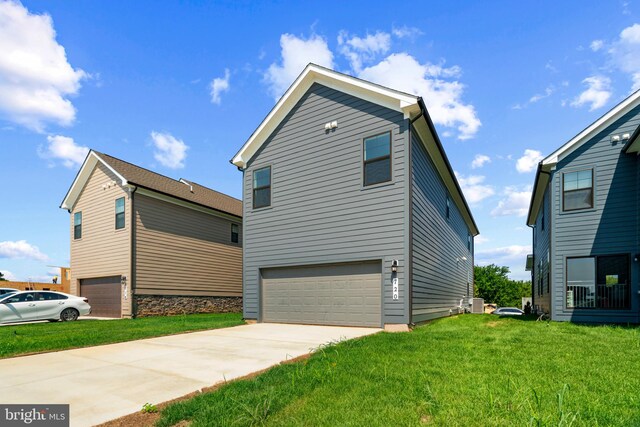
[231,64,478,330]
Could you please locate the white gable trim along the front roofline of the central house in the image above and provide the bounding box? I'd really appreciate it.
[231,64,420,168]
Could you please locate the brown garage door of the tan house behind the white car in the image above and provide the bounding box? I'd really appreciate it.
[80,276,121,317]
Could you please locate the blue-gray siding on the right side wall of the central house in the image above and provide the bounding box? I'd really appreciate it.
[411,132,473,323]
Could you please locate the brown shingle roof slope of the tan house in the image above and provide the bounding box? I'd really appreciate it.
[94,151,242,217]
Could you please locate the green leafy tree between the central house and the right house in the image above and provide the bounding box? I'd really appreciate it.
[474,264,531,307]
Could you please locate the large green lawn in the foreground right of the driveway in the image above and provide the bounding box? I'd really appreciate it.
[158,315,640,427]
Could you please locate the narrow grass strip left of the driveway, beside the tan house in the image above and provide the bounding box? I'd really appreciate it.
[0,313,244,358]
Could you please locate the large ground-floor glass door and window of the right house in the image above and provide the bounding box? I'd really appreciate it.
[566,255,631,310]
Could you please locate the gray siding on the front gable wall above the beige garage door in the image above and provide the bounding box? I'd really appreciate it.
[243,84,409,323]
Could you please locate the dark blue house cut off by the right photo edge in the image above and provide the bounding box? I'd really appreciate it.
[527,91,640,323]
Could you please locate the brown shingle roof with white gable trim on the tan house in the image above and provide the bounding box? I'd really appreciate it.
[60,150,242,217]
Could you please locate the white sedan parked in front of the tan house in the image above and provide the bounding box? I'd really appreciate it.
[0,291,91,323]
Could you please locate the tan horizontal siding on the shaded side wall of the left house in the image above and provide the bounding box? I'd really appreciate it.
[134,193,242,296]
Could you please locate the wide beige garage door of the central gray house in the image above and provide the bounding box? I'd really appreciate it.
[262,263,382,327]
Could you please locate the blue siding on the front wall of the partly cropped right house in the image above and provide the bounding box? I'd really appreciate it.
[551,107,640,322]
